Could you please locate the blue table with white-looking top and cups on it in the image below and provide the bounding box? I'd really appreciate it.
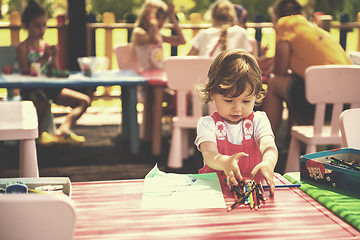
[0,70,146,154]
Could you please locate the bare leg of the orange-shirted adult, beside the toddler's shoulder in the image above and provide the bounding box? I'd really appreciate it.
[263,75,291,135]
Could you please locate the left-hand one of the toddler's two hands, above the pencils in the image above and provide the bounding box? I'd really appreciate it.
[223,152,249,189]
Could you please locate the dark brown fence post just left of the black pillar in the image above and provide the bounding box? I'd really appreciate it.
[56,14,68,70]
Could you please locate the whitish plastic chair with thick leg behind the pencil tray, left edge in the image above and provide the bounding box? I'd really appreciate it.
[0,101,39,177]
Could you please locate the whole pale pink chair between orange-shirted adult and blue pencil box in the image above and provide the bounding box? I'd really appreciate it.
[285,65,360,172]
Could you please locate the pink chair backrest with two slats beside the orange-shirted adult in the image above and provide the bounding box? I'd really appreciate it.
[305,65,360,136]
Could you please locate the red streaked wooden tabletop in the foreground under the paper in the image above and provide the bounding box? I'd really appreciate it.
[72,175,360,239]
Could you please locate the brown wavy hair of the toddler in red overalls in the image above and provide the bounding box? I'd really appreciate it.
[200,49,266,106]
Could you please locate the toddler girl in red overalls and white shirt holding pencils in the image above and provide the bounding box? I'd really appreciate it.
[195,50,278,195]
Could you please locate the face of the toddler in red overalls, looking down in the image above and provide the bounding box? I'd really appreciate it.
[211,87,255,124]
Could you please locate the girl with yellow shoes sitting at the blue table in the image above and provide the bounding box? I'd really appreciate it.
[15,0,90,145]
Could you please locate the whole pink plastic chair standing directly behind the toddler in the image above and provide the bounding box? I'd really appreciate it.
[165,56,214,168]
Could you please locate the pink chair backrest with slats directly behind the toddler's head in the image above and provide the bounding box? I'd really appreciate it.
[165,56,214,118]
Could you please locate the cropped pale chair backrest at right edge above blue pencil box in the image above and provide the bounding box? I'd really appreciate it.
[339,108,360,149]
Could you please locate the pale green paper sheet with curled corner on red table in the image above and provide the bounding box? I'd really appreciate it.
[141,165,226,209]
